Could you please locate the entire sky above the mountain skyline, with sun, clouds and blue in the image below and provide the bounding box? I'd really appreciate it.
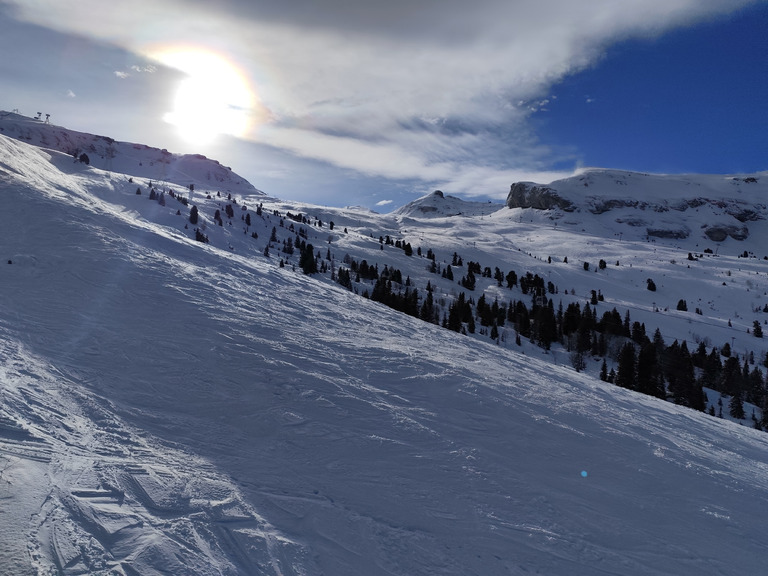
[0,0,768,211]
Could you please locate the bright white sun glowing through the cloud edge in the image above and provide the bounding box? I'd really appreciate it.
[154,48,256,144]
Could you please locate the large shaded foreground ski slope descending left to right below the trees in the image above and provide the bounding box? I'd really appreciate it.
[0,127,768,576]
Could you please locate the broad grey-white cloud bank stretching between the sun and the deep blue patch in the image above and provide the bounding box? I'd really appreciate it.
[4,0,749,195]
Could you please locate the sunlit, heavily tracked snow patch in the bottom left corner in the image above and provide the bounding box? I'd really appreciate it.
[0,345,312,574]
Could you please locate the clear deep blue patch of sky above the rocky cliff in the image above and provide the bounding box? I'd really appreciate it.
[533,3,768,173]
